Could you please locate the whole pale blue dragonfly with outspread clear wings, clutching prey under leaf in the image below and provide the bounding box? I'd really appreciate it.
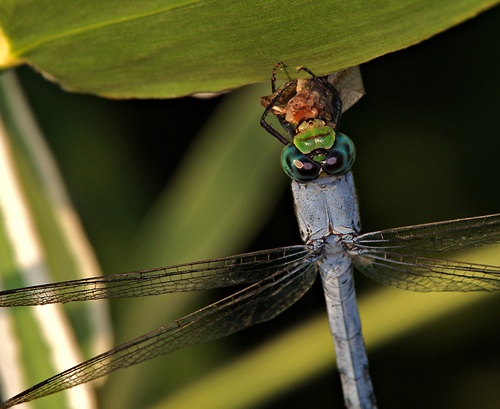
[0,66,500,409]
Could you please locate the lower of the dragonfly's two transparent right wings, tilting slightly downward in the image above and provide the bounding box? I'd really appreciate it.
[354,251,500,292]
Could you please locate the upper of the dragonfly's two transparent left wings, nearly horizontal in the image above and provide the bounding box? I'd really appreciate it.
[0,246,310,307]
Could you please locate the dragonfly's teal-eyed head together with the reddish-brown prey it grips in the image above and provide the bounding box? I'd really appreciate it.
[261,64,363,183]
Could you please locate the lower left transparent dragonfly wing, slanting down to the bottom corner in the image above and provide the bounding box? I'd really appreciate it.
[0,260,316,409]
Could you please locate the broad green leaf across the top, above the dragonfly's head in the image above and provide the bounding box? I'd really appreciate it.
[0,0,497,98]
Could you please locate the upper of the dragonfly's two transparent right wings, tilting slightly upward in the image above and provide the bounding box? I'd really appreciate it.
[352,213,500,254]
